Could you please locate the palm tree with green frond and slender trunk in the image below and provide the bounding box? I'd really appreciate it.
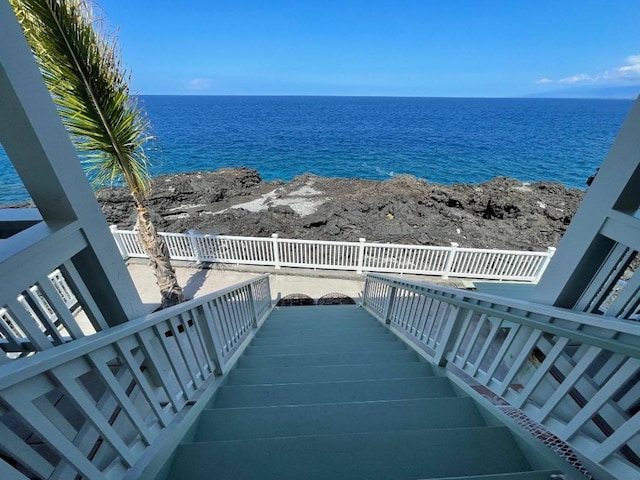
[10,0,184,307]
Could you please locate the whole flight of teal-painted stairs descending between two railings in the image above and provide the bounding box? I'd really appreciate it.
[168,306,558,480]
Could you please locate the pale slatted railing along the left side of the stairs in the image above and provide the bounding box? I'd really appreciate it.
[0,275,271,479]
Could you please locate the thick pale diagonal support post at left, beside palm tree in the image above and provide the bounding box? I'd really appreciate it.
[0,1,145,325]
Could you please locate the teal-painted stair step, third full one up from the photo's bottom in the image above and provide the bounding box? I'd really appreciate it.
[212,377,455,408]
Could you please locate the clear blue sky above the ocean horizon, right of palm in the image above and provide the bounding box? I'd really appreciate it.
[98,0,640,97]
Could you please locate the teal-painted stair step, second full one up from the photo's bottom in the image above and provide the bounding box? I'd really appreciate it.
[194,397,485,442]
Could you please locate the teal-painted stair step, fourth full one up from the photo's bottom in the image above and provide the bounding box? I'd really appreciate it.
[227,362,433,385]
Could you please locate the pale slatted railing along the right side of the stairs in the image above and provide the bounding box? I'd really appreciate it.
[363,274,640,478]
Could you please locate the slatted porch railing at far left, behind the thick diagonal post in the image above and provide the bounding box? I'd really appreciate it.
[0,222,114,365]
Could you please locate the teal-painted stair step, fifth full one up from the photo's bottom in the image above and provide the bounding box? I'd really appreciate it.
[237,350,418,368]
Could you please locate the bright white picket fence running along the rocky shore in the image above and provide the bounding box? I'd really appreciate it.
[111,227,555,282]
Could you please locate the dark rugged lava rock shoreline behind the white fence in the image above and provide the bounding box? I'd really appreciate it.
[96,168,584,250]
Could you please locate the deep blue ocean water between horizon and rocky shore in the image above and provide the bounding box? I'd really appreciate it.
[0,96,632,203]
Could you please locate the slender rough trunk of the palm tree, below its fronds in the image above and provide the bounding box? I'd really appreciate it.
[132,193,185,308]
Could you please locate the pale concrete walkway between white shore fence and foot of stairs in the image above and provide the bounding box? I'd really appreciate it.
[127,259,470,307]
